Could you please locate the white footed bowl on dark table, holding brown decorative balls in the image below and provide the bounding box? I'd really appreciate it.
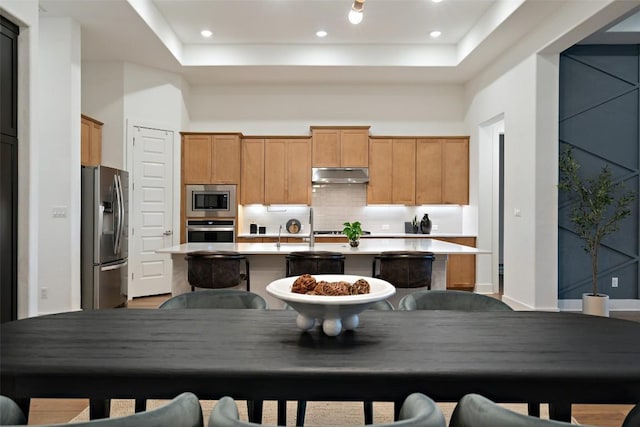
[267,274,396,336]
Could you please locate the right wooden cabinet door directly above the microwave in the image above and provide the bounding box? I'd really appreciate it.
[211,135,241,184]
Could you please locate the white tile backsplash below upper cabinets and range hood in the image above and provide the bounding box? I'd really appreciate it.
[239,184,465,234]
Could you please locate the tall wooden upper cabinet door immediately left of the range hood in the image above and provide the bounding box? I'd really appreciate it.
[287,139,311,205]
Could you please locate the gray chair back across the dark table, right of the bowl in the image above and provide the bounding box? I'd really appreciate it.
[398,290,512,311]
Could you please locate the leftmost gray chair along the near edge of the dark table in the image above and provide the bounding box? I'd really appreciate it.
[0,392,203,427]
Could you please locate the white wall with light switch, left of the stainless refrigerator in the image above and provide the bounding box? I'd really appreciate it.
[37,18,80,314]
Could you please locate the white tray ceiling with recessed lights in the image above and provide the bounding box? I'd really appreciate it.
[40,0,640,84]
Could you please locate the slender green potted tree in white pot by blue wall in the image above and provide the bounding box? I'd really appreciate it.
[558,148,636,316]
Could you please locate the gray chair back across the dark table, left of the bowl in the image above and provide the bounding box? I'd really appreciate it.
[158,289,267,310]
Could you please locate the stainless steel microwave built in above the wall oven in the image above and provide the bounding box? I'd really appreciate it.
[185,184,237,218]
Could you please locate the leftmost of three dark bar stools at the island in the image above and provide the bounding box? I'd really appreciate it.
[184,251,251,291]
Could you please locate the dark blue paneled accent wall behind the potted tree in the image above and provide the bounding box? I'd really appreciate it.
[558,45,640,299]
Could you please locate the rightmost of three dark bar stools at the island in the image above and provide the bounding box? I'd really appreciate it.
[371,251,435,289]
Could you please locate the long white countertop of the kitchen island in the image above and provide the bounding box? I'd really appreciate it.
[157,234,491,255]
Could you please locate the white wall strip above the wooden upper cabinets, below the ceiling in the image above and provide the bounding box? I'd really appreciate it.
[184,84,466,135]
